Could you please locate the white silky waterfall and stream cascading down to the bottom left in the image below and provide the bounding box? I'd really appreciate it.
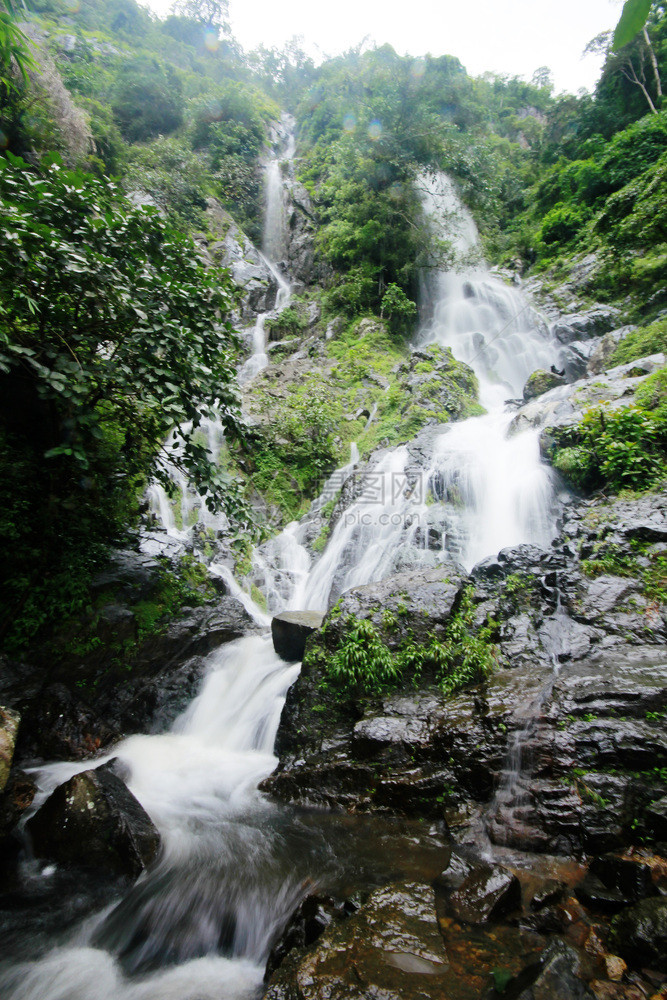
[0,168,568,1000]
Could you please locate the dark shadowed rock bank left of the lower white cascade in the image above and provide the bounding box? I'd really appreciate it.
[0,551,256,762]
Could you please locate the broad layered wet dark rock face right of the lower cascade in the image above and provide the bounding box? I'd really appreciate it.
[263,490,667,854]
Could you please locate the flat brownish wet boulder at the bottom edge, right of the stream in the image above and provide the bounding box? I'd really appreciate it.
[265,883,458,1000]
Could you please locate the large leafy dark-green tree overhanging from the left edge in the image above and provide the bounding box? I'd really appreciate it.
[0,156,245,635]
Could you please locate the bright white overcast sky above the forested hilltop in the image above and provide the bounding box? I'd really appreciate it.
[147,0,622,93]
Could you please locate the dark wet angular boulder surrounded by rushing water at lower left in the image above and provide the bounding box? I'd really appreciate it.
[26,764,160,878]
